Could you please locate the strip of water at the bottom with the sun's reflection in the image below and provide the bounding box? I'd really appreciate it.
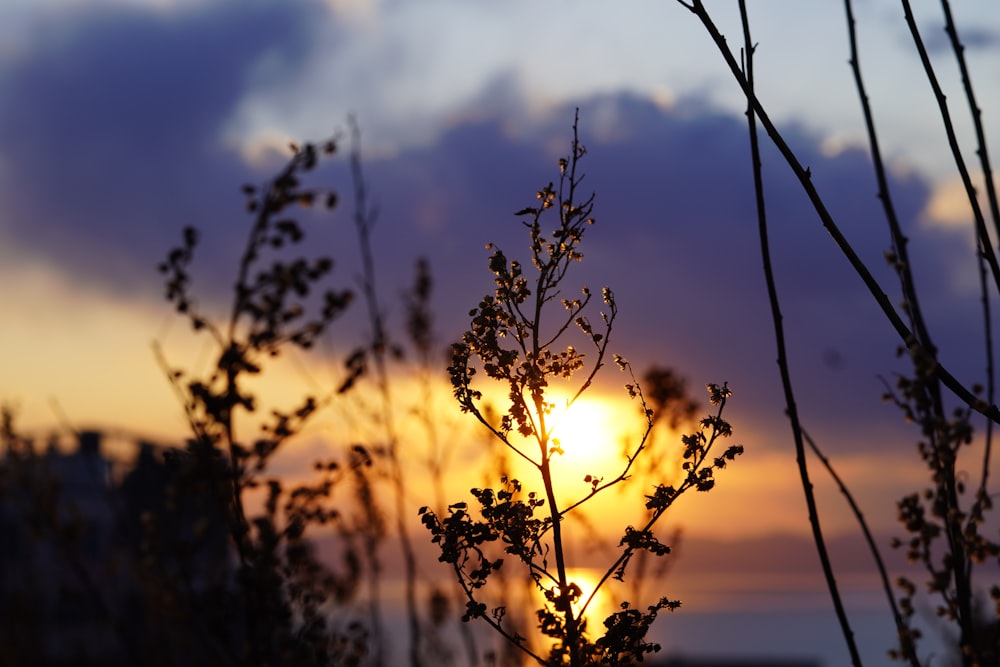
[376,569,943,667]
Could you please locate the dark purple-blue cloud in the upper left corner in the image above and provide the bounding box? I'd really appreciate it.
[0,2,324,296]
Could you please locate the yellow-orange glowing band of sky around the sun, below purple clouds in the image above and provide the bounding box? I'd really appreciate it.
[0,263,925,538]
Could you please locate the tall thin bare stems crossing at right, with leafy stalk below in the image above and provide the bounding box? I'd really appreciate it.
[678,0,1000,667]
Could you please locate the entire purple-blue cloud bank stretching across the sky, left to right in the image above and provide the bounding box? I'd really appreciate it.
[0,3,975,462]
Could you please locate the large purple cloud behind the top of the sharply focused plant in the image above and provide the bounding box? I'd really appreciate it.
[352,95,973,460]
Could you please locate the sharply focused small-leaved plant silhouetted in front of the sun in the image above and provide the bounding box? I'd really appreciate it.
[420,115,742,666]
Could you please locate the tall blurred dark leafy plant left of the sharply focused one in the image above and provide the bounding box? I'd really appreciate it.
[153,140,368,665]
